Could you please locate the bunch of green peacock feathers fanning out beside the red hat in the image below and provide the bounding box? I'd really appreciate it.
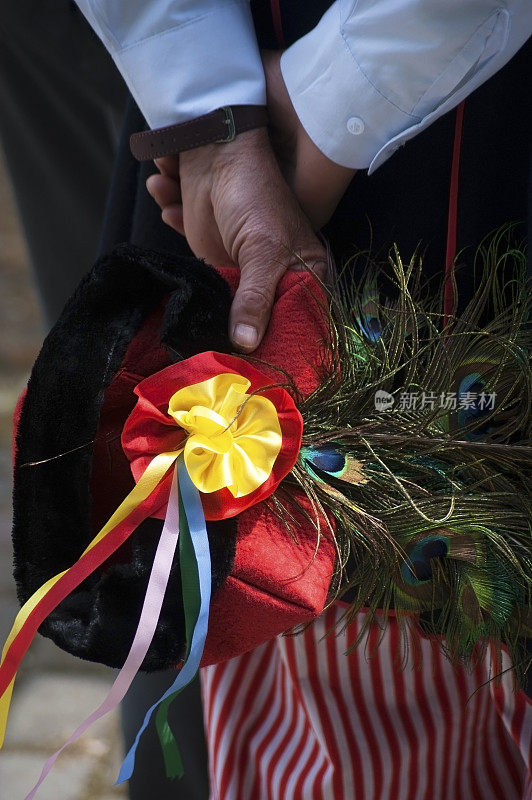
[275,228,532,674]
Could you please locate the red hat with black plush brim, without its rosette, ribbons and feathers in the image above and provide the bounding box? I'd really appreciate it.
[13,245,335,671]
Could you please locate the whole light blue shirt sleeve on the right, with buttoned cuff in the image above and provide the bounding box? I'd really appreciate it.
[281,0,532,172]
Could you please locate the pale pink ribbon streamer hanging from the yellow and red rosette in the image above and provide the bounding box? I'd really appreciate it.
[25,467,179,800]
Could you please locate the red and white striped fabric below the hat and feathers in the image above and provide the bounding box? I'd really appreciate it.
[202,604,532,800]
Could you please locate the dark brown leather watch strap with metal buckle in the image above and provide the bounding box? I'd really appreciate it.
[129,106,268,161]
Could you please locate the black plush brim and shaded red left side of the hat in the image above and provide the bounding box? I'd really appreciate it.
[13,246,236,670]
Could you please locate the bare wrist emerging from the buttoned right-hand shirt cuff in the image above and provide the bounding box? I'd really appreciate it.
[261,50,356,230]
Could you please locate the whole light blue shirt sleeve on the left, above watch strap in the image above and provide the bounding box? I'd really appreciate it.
[76,0,266,128]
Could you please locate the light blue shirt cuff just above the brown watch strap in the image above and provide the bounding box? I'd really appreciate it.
[105,2,266,128]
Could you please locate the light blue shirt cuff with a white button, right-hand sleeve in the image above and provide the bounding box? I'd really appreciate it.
[281,3,421,169]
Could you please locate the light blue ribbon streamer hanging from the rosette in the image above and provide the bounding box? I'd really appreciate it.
[116,456,211,784]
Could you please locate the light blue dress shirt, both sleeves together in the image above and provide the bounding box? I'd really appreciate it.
[76,0,532,172]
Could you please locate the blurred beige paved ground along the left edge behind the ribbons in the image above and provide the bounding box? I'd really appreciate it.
[0,152,125,800]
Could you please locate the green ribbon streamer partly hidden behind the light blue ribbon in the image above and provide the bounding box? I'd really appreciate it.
[155,494,201,778]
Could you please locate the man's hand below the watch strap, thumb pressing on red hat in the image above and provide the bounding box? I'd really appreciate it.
[147,128,326,352]
